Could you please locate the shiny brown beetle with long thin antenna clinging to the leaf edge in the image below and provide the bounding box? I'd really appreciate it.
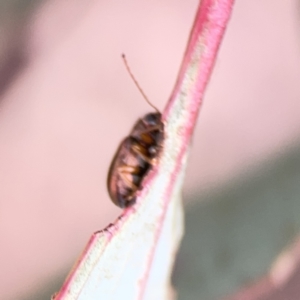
[107,55,164,208]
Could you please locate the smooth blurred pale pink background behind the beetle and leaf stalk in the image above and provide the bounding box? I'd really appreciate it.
[0,0,300,299]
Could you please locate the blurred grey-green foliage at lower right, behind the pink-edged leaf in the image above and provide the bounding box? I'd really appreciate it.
[174,144,300,300]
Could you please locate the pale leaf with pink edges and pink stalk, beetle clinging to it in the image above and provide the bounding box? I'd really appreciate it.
[55,0,233,300]
